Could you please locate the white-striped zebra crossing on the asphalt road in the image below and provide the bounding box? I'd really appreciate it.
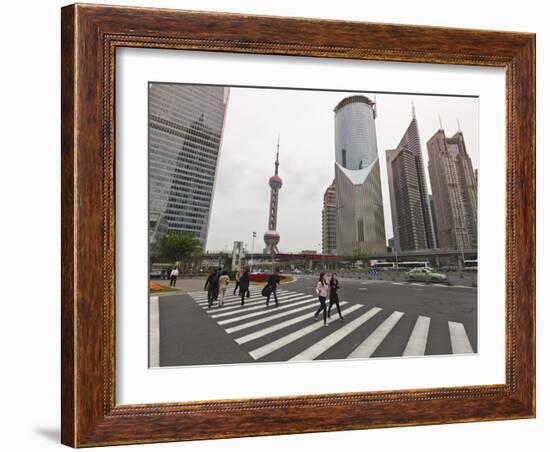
[188,286,474,361]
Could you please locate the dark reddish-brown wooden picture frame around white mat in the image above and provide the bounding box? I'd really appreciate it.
[61,4,535,447]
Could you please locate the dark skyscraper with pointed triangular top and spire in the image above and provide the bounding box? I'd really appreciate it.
[386,107,436,251]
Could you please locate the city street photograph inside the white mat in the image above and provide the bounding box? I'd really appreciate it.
[149,81,483,368]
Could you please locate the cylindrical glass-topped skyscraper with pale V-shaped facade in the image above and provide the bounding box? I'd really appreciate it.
[334,96,386,255]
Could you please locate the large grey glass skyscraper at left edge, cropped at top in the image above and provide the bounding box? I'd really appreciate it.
[149,83,229,248]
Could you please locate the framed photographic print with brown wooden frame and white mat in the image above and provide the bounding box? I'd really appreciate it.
[62,4,535,447]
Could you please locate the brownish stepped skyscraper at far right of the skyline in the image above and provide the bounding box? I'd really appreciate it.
[428,129,477,250]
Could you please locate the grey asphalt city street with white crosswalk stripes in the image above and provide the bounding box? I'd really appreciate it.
[150,276,477,367]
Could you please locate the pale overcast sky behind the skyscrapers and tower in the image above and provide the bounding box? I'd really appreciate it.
[206,88,479,252]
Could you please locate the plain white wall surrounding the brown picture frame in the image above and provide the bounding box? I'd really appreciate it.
[0,0,550,452]
